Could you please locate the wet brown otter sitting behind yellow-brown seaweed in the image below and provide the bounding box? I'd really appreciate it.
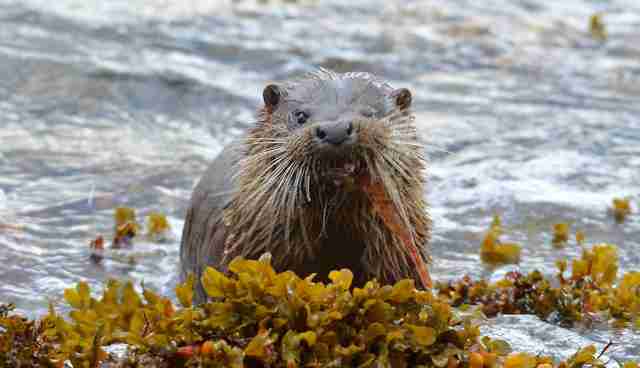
[180,69,431,303]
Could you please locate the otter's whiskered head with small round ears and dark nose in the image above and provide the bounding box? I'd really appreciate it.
[250,70,417,190]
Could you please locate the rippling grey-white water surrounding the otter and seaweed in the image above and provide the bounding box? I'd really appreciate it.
[0,0,640,358]
